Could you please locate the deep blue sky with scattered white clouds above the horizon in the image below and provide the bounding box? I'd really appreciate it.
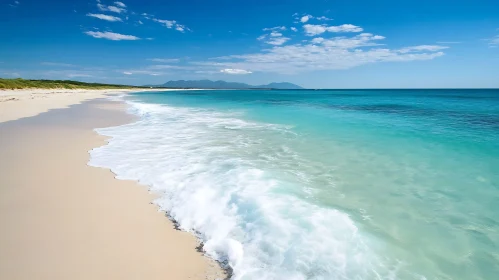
[0,0,499,88]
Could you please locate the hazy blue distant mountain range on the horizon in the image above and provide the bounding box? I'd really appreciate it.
[152,80,303,89]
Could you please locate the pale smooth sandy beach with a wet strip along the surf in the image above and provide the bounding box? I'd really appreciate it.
[0,90,225,280]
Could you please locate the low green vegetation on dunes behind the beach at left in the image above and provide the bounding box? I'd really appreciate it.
[0,78,143,90]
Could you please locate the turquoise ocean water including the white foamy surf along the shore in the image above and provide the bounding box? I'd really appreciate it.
[89,90,499,280]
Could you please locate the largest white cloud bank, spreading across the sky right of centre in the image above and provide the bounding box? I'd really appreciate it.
[205,24,448,74]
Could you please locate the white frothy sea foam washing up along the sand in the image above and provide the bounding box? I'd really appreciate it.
[89,99,397,280]
